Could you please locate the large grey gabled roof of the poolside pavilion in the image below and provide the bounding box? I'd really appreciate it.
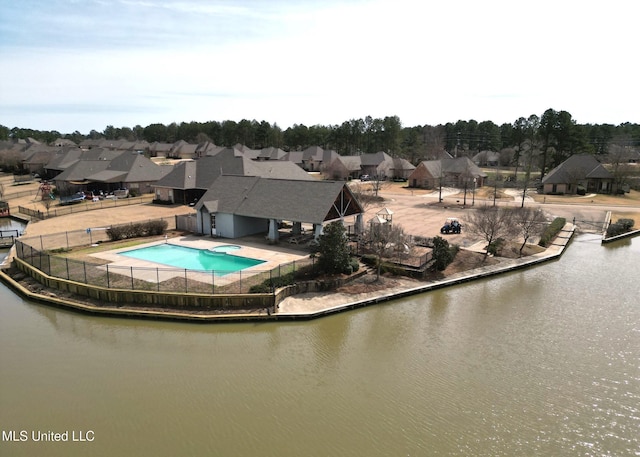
[196,176,363,224]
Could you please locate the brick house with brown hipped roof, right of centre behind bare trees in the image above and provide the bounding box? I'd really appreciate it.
[408,157,487,189]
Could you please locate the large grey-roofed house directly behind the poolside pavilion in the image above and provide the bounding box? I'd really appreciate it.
[154,148,312,205]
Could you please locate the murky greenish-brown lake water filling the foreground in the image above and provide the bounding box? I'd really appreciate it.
[0,237,640,456]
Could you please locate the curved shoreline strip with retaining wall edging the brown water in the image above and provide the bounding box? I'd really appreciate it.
[0,223,576,323]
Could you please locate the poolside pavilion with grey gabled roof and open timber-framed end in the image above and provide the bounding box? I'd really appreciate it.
[195,176,364,242]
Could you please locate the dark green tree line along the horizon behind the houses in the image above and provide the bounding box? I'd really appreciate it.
[0,109,640,169]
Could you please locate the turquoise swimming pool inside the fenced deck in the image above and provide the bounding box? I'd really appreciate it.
[120,243,265,276]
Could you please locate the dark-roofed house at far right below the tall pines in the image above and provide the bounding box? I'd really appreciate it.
[542,154,615,194]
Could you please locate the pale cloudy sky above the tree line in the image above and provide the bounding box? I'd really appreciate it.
[0,0,640,134]
